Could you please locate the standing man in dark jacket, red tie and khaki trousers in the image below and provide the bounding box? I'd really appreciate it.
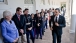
[12,7,26,43]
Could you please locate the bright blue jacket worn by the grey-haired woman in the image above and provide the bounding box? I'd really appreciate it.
[1,20,19,43]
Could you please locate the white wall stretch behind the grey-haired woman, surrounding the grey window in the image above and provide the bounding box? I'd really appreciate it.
[0,0,34,18]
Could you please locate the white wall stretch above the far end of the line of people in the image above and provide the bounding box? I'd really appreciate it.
[36,0,60,12]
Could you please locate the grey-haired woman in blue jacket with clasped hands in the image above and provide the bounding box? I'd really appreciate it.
[1,11,19,43]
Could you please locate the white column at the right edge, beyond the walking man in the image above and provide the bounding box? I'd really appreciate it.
[70,0,76,33]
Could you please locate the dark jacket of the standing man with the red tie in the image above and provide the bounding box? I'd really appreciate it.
[12,14,26,36]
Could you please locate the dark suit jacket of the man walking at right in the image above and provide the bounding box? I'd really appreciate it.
[49,15,66,35]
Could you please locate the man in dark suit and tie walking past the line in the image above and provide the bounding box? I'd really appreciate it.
[49,8,66,43]
